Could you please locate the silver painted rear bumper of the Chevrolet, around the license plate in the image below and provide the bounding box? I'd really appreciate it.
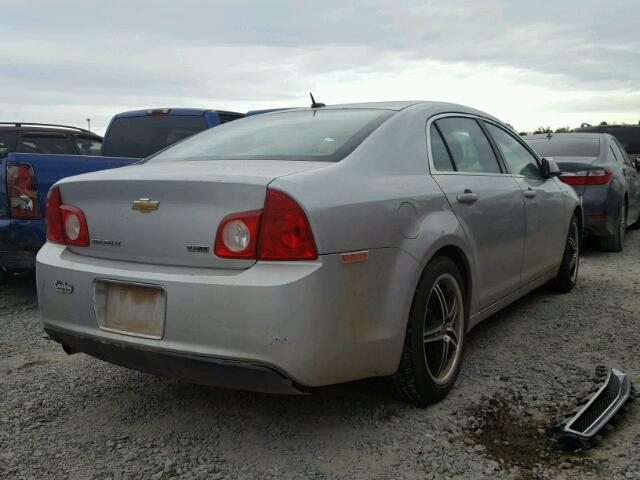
[37,243,415,387]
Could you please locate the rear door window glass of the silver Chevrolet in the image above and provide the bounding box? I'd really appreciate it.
[436,117,500,173]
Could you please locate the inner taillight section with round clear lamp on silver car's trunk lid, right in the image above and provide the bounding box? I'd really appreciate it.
[213,210,262,258]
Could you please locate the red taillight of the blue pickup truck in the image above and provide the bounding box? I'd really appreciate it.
[7,163,40,219]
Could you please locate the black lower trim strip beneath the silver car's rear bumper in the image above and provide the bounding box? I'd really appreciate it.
[45,327,304,394]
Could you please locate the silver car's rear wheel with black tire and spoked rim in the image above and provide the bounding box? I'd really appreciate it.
[391,257,469,407]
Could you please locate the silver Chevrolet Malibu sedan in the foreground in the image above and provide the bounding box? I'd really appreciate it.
[37,102,582,405]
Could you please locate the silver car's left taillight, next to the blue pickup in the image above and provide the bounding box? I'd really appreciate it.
[47,187,89,247]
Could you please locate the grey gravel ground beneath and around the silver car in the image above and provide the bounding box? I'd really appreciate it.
[0,231,640,480]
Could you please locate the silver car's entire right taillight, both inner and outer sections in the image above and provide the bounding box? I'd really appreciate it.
[214,188,318,260]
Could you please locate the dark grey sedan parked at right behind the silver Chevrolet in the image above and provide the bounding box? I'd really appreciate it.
[525,133,640,252]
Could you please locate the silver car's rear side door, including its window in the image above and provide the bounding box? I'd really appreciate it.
[428,115,525,308]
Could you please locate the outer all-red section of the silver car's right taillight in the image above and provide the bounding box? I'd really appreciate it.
[258,188,318,260]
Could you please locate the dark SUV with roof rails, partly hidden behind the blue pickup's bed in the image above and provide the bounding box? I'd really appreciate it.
[0,122,102,155]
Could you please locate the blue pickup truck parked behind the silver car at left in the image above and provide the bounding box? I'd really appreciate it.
[0,108,245,278]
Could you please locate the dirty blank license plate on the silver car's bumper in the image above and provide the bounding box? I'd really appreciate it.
[94,281,166,339]
